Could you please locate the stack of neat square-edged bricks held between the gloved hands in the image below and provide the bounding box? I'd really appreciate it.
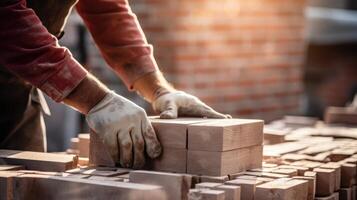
[90,117,263,176]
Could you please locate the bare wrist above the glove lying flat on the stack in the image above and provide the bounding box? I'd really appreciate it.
[133,71,175,103]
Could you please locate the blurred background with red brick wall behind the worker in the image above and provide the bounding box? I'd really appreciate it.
[46,0,357,151]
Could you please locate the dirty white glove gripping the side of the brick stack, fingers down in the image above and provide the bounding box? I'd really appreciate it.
[86,92,161,169]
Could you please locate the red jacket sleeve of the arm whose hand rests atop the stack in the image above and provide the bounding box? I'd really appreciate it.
[76,0,158,89]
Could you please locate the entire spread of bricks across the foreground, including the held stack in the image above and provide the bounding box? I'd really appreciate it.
[0,117,357,200]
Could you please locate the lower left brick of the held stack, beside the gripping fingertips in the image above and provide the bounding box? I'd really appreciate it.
[147,147,187,173]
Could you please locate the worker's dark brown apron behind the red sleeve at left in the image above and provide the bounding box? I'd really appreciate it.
[0,0,77,152]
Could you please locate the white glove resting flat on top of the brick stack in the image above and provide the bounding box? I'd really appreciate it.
[152,91,232,119]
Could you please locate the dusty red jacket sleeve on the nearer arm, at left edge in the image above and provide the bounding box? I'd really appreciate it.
[0,0,87,102]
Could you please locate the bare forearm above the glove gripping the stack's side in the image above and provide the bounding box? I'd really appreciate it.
[63,74,109,114]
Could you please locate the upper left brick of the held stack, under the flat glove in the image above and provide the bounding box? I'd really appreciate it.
[150,117,211,149]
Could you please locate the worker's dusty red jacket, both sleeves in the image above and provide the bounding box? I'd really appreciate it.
[0,0,157,102]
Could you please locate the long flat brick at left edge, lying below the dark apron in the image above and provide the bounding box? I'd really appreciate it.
[0,150,78,171]
